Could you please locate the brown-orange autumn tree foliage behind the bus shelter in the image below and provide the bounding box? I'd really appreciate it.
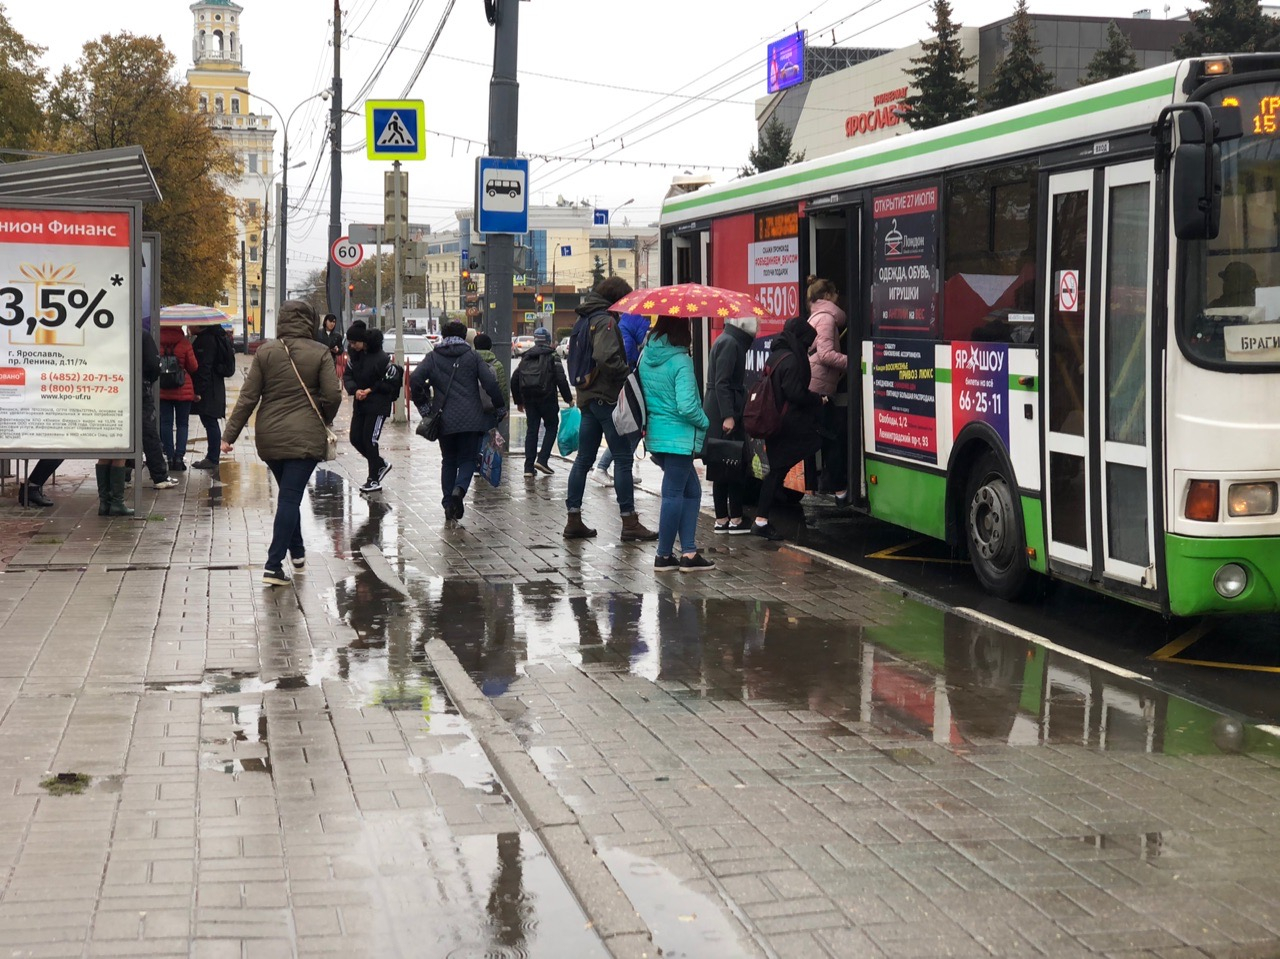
[0,5,238,303]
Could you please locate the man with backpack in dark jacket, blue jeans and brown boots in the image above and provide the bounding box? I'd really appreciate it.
[564,277,658,543]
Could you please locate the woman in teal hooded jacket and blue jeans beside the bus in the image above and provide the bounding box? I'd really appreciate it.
[639,316,716,572]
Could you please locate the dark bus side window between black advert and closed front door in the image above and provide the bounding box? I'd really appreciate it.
[942,163,1038,343]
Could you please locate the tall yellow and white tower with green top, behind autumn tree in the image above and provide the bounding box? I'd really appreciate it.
[187,0,275,335]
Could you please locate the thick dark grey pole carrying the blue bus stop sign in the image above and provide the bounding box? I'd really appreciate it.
[484,0,520,439]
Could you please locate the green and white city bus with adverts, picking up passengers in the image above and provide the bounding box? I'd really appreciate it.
[662,54,1280,616]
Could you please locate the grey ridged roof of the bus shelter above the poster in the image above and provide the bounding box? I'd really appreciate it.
[0,146,161,204]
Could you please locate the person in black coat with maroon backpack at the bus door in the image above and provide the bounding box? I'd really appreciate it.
[751,316,827,539]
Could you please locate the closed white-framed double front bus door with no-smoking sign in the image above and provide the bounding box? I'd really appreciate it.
[1043,161,1157,589]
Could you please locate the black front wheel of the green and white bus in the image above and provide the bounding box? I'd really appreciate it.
[960,453,1030,599]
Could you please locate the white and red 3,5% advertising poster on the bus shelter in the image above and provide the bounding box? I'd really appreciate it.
[0,207,133,451]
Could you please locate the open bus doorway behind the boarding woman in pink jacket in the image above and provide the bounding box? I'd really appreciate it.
[800,202,867,502]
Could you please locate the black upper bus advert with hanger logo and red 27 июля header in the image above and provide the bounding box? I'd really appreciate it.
[872,186,940,337]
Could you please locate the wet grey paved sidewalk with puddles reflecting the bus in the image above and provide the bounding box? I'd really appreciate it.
[0,407,1280,958]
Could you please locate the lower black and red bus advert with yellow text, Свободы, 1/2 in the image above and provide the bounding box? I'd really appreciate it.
[872,339,938,463]
